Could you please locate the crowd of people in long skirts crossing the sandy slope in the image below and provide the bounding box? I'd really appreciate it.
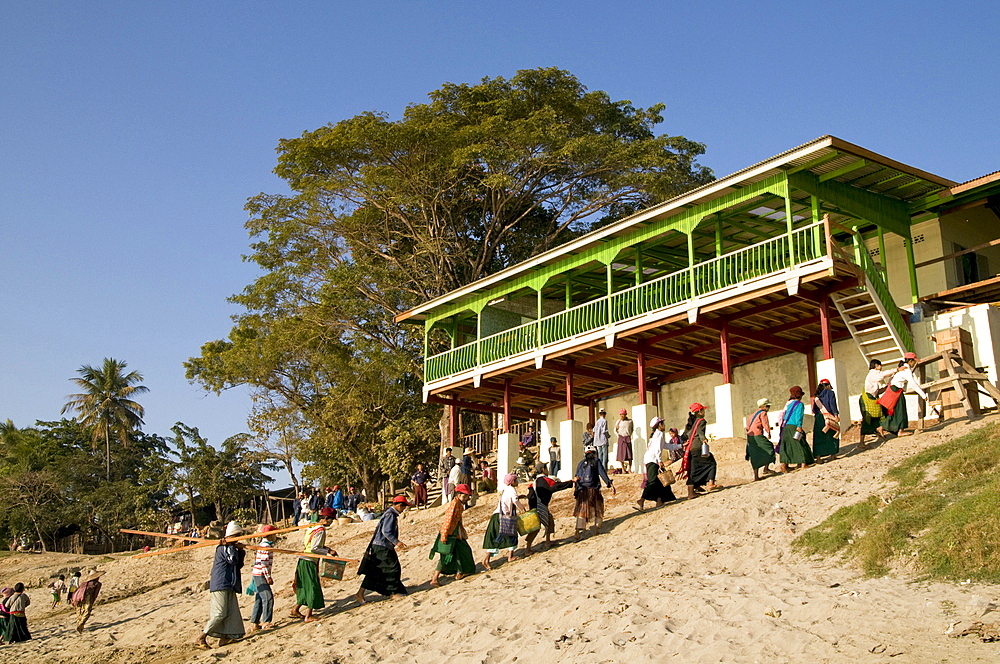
[0,353,926,649]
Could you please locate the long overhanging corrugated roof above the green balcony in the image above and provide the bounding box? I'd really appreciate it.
[396,135,956,322]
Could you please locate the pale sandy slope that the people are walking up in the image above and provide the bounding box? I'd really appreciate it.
[0,416,1000,664]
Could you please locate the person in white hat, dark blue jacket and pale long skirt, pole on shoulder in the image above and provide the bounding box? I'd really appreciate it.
[195,521,247,650]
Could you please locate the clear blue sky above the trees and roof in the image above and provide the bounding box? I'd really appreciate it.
[0,0,1000,482]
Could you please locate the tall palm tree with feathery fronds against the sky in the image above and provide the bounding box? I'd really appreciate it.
[62,357,149,482]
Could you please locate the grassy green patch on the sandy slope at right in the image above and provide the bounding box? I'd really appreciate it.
[793,425,1000,582]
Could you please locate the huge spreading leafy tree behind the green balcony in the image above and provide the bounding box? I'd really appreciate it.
[186,68,711,484]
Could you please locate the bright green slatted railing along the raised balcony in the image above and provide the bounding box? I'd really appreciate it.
[424,222,828,382]
